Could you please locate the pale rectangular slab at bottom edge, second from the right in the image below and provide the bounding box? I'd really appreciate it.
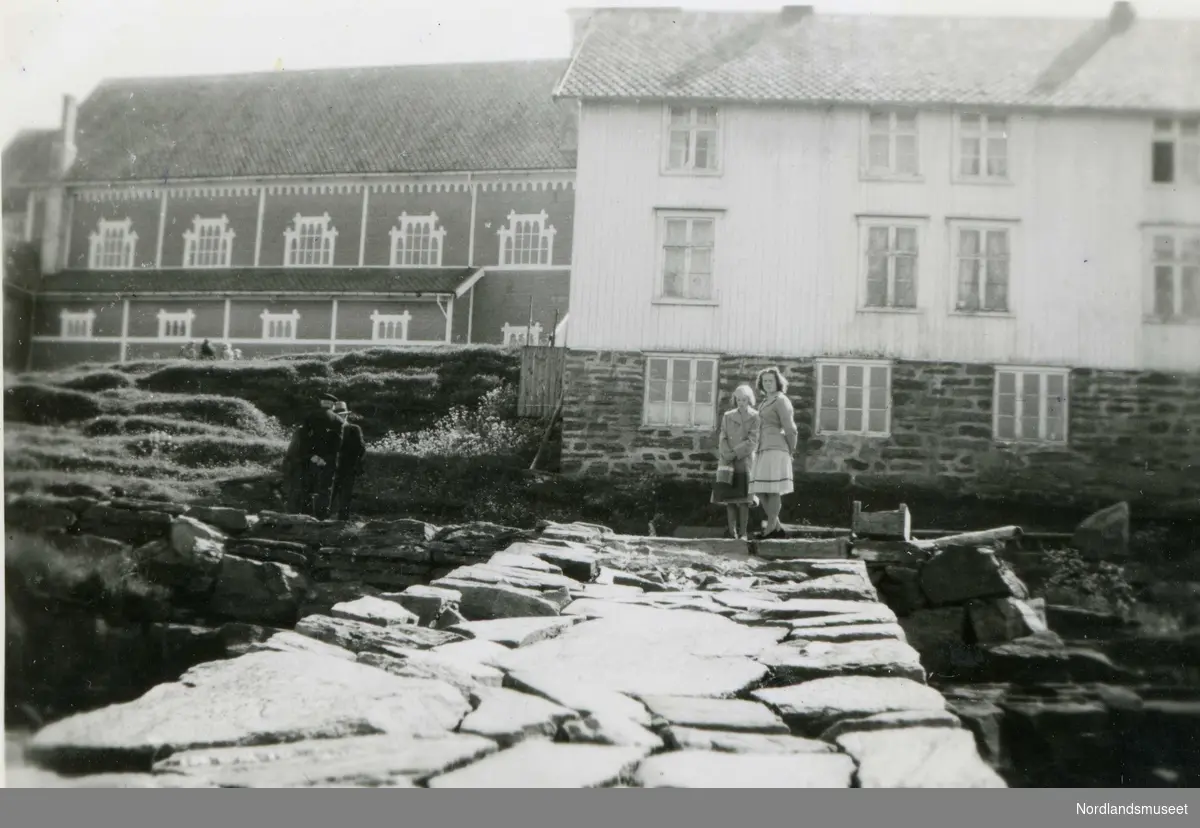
[635,750,854,788]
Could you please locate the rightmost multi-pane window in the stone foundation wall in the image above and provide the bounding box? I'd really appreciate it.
[992,368,1069,443]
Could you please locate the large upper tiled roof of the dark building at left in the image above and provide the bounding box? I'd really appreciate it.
[70,60,575,181]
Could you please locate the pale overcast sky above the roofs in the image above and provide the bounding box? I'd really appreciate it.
[7,0,1200,143]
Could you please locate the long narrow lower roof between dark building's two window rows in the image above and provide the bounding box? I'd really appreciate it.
[38,268,474,295]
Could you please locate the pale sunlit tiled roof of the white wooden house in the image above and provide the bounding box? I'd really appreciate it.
[556,10,1200,112]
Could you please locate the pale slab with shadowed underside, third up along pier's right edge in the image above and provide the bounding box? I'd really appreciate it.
[751,676,946,736]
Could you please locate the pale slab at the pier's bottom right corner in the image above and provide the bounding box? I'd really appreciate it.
[838,727,1008,787]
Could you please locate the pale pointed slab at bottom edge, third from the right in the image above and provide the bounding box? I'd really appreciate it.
[428,739,649,788]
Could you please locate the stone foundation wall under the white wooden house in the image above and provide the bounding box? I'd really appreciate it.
[563,350,1200,515]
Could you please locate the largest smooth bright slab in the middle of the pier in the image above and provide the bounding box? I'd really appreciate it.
[500,605,785,696]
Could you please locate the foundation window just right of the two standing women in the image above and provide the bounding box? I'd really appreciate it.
[817,361,892,434]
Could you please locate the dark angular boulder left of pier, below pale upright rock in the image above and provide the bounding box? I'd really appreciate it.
[209,554,308,625]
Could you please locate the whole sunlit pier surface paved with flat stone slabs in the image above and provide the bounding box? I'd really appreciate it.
[18,524,1004,788]
